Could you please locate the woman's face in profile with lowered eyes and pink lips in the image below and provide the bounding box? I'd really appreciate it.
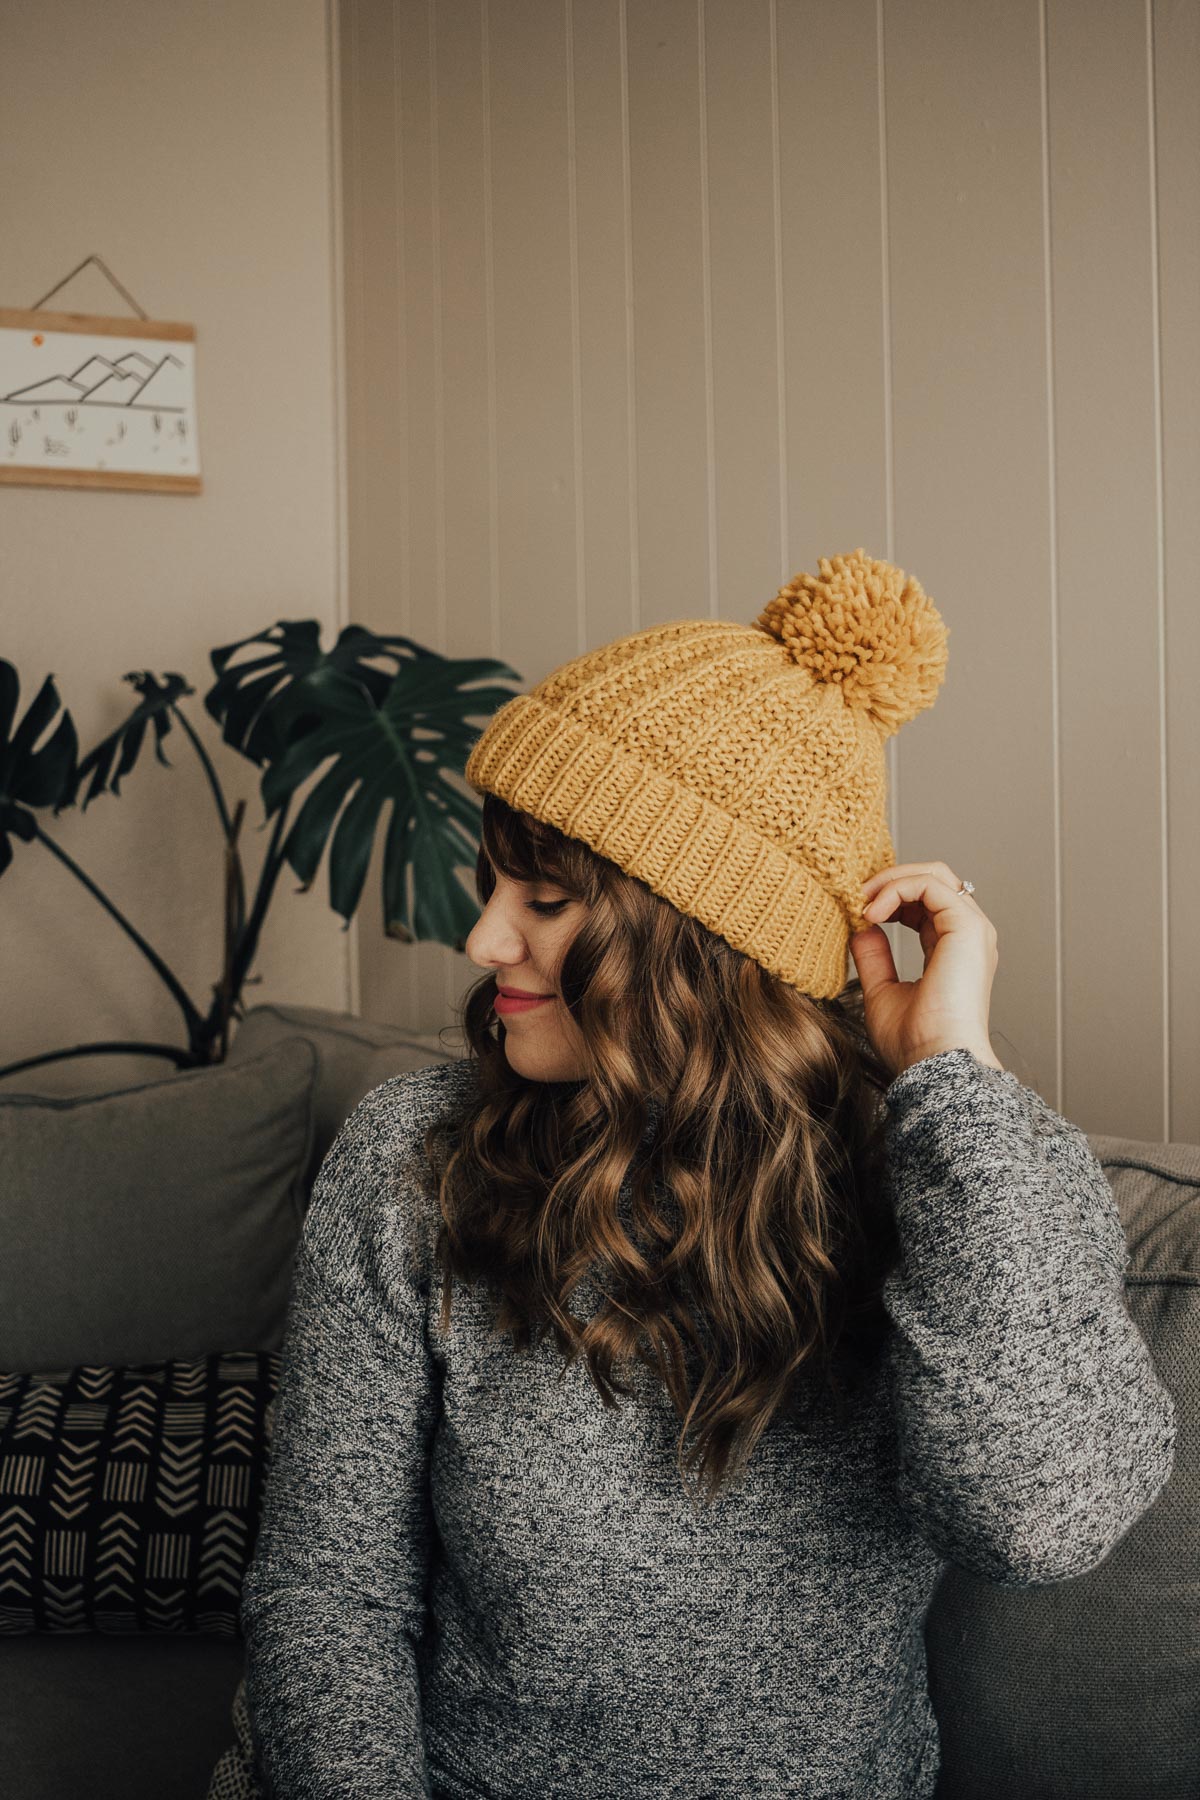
[466,871,585,1082]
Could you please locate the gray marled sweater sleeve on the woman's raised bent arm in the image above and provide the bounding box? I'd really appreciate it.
[882,1049,1177,1588]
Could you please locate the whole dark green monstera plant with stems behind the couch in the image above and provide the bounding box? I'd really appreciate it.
[0,619,520,1076]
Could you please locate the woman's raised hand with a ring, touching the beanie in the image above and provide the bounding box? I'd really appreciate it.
[849,862,1004,1080]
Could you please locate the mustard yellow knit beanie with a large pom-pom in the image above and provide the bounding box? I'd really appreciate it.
[466,549,950,999]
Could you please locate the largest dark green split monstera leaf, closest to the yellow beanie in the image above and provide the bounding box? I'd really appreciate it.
[263,652,520,950]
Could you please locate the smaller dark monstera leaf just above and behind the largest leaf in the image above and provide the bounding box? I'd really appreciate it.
[203,619,441,767]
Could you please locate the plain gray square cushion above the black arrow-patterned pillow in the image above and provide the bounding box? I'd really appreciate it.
[0,1039,317,1375]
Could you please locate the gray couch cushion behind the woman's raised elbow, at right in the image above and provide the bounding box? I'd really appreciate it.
[925,1136,1200,1800]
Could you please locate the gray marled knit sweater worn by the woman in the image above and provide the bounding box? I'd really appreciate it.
[241,1049,1175,1800]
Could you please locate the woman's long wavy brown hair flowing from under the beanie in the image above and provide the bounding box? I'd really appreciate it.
[425,796,898,1503]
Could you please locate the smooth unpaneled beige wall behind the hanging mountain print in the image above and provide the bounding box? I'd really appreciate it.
[0,0,352,1091]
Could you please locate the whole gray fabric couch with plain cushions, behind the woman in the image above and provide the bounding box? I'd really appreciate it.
[0,1006,1200,1800]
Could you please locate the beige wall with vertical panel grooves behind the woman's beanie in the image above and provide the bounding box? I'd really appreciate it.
[340,0,1200,1141]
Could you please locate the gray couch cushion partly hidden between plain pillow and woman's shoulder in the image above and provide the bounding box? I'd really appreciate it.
[228,1006,456,1188]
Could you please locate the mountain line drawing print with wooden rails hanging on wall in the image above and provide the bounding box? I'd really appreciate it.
[0,308,201,493]
